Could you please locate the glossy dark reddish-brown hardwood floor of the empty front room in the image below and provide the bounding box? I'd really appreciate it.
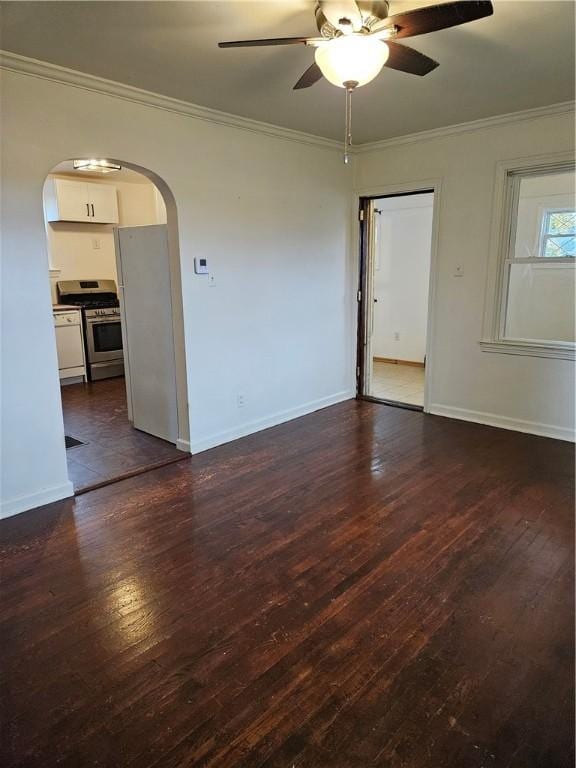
[0,401,574,768]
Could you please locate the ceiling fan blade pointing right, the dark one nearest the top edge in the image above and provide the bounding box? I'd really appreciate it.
[374,0,494,39]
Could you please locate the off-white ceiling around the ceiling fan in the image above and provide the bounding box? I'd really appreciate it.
[0,0,575,143]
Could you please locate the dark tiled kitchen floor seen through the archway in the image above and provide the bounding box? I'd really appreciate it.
[60,376,187,493]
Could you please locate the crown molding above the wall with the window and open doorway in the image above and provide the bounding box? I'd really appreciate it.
[354,101,576,154]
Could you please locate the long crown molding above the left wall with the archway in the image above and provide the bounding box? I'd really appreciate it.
[0,50,342,152]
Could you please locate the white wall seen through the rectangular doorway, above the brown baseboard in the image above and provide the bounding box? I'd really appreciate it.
[372,194,434,363]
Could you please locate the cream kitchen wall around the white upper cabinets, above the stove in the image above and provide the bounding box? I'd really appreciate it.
[46,173,166,302]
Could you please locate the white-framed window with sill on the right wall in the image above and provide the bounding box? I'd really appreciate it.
[482,164,576,359]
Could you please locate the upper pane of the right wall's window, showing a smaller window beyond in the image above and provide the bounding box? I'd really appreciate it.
[511,171,576,259]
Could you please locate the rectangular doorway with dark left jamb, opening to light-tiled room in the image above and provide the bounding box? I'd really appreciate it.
[357,189,434,410]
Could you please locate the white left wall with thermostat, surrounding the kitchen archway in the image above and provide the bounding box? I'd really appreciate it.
[2,71,355,514]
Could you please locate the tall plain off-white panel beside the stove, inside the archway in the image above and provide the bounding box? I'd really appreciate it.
[116,224,178,443]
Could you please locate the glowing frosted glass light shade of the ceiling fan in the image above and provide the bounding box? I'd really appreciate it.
[315,35,389,88]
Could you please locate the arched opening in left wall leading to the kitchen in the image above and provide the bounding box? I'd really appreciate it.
[43,160,189,493]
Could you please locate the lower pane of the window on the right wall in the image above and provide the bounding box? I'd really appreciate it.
[504,261,576,341]
